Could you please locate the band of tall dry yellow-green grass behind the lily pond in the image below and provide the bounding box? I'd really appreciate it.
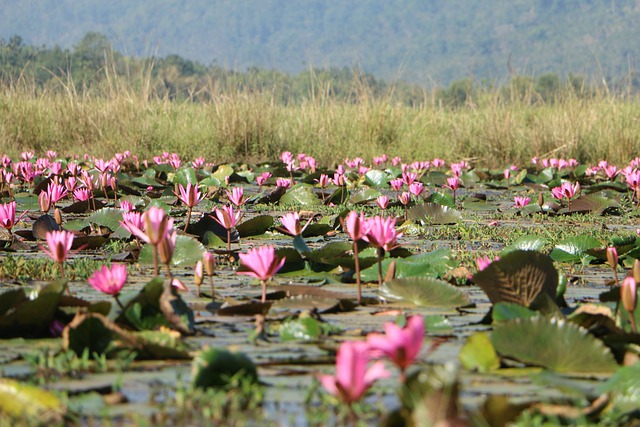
[0,70,640,167]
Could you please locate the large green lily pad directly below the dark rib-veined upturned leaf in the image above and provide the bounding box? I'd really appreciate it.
[491,316,618,374]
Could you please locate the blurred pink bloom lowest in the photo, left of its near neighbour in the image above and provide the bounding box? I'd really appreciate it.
[318,341,391,412]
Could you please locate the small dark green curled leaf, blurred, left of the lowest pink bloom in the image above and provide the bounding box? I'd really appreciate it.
[192,348,258,388]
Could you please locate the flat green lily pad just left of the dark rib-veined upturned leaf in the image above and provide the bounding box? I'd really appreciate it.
[380,277,469,308]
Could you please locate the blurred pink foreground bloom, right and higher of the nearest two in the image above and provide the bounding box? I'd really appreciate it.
[367,316,425,382]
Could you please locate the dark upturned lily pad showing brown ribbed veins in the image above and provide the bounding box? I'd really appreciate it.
[473,250,558,307]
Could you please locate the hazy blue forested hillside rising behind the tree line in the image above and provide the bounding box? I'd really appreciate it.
[0,0,640,85]
